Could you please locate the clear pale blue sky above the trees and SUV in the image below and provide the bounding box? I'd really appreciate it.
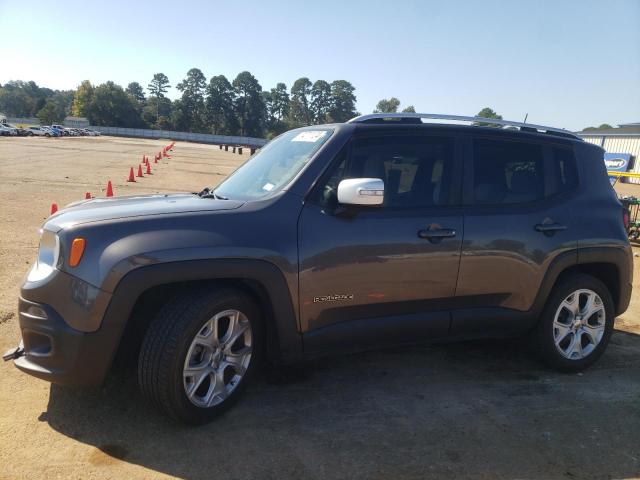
[0,0,640,129]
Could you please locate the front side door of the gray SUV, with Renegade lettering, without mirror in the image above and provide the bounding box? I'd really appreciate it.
[299,131,464,352]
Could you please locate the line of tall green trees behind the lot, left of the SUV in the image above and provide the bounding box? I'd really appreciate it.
[0,68,358,138]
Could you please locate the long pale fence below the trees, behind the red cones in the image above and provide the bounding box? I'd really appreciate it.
[90,127,268,148]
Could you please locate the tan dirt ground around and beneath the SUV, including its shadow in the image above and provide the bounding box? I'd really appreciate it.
[0,137,640,479]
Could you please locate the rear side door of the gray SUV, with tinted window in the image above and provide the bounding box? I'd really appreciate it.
[452,136,584,334]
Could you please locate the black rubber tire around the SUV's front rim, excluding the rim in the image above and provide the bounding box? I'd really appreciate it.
[138,287,264,425]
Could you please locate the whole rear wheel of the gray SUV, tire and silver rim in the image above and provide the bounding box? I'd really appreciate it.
[533,274,615,372]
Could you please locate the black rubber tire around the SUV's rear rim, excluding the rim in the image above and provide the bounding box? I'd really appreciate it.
[531,273,615,373]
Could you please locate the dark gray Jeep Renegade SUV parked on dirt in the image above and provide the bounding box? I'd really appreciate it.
[5,114,633,423]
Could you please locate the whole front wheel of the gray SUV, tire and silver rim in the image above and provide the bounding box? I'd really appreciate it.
[138,288,263,424]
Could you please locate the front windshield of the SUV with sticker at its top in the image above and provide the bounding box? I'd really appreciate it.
[215,129,333,200]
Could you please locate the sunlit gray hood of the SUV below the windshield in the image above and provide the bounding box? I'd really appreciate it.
[45,193,245,232]
